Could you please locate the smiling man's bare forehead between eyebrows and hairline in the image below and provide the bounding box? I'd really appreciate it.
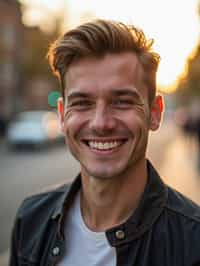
[65,52,144,95]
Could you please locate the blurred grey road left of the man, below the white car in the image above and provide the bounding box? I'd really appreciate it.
[0,144,79,255]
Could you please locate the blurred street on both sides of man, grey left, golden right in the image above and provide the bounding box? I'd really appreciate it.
[0,122,200,266]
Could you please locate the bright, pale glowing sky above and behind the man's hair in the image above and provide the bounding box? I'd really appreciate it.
[21,0,200,92]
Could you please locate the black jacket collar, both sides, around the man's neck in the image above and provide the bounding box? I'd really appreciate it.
[52,161,167,246]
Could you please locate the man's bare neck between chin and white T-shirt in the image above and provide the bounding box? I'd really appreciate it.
[81,161,147,232]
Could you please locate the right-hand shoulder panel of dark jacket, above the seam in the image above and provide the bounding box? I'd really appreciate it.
[166,187,200,226]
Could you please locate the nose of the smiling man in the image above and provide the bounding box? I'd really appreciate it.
[90,103,116,134]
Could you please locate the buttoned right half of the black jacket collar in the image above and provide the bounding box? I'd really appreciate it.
[106,161,167,246]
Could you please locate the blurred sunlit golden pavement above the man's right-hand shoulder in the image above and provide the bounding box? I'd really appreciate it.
[160,132,200,204]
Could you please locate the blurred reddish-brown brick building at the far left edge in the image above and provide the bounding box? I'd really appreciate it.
[0,0,23,134]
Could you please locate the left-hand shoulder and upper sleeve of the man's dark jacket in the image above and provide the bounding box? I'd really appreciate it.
[12,184,74,265]
